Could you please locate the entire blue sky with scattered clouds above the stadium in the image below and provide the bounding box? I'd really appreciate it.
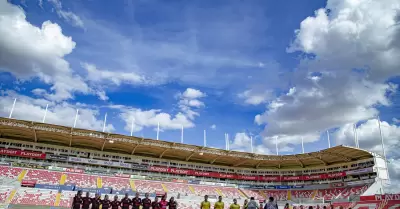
[0,0,400,192]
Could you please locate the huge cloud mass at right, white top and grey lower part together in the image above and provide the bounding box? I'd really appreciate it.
[255,0,400,149]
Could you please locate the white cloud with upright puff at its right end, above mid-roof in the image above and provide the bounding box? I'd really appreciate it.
[119,88,206,132]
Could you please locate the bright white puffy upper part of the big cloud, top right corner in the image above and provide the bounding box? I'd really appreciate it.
[288,0,400,81]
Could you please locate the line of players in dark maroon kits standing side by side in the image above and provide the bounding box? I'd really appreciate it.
[71,191,178,209]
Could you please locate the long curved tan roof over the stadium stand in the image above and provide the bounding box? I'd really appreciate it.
[0,118,373,169]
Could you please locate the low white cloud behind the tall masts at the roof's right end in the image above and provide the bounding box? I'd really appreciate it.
[333,119,400,193]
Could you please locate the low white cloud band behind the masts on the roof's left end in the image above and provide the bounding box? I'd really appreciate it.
[0,91,115,132]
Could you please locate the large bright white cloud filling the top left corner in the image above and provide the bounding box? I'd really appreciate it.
[0,0,90,101]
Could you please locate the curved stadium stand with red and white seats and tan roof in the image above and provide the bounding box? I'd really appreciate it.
[0,118,400,209]
